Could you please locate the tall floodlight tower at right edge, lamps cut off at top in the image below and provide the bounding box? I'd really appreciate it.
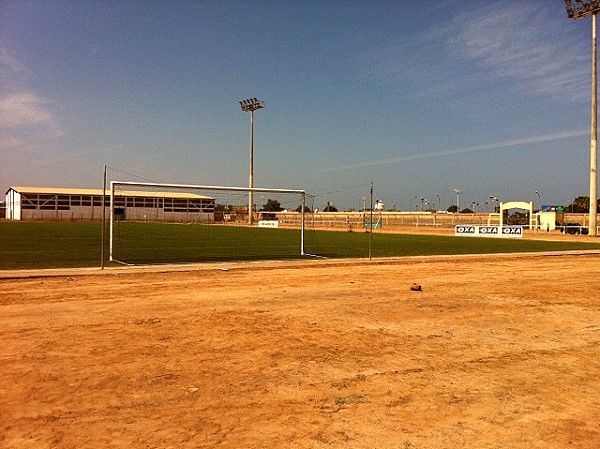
[565,0,600,237]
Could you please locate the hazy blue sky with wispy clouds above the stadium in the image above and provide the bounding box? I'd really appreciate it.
[0,0,592,211]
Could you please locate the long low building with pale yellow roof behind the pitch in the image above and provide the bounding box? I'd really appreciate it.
[6,187,215,223]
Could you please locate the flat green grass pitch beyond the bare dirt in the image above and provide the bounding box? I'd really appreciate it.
[0,222,600,270]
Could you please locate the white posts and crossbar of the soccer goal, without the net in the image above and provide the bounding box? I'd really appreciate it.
[108,181,310,262]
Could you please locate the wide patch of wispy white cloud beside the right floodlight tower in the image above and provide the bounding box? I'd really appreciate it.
[354,2,589,104]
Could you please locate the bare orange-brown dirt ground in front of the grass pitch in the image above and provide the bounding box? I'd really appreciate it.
[0,250,600,449]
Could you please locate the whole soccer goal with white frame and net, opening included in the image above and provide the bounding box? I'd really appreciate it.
[109,181,314,264]
